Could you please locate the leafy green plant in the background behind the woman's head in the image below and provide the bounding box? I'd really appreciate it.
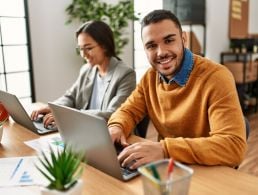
[65,0,139,55]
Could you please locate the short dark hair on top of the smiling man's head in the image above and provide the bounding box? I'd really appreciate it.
[141,9,182,33]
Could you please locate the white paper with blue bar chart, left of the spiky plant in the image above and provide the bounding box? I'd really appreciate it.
[0,156,48,187]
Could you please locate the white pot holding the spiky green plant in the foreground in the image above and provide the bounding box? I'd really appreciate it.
[41,180,83,195]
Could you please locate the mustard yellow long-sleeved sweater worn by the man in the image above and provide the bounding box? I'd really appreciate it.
[108,55,246,166]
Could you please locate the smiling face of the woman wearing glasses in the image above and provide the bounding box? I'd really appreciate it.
[77,33,108,66]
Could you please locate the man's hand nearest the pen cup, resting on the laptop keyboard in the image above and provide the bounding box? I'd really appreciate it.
[118,141,164,169]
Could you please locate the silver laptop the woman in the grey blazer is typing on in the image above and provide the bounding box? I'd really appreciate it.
[0,90,57,135]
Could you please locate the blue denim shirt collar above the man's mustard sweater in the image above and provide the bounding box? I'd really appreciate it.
[160,48,194,86]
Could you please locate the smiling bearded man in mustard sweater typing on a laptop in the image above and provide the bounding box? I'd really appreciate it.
[108,10,246,169]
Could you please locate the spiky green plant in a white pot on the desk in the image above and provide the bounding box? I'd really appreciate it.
[35,144,83,195]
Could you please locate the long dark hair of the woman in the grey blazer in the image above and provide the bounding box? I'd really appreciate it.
[76,21,119,59]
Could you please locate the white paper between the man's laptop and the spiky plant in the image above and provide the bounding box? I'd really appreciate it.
[24,134,64,153]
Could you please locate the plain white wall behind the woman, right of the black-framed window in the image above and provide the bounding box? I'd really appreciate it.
[28,0,133,103]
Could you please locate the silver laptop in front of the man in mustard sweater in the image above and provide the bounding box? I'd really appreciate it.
[48,102,139,181]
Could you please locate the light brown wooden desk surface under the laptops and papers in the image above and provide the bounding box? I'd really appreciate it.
[0,120,258,195]
